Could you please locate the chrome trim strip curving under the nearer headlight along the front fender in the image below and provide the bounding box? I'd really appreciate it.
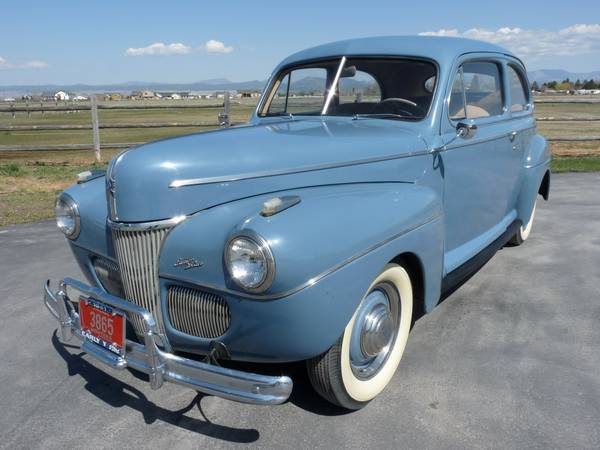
[158,214,441,300]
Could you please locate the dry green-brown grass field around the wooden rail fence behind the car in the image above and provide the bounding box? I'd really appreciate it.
[0,99,600,226]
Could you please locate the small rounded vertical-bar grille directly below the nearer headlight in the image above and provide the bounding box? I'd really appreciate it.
[167,286,231,338]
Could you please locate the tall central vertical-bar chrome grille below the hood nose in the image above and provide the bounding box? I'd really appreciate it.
[113,228,169,335]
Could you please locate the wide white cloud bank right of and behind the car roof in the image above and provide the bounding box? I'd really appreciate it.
[419,24,600,59]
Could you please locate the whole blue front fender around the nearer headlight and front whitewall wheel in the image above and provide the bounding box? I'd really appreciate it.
[160,183,443,362]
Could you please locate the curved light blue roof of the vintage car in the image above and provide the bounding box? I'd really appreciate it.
[278,36,516,68]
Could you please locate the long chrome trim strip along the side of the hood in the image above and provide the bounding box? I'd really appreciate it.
[169,150,431,188]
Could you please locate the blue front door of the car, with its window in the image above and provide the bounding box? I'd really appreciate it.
[441,55,520,273]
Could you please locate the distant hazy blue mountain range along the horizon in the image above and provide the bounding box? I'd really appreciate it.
[0,69,600,97]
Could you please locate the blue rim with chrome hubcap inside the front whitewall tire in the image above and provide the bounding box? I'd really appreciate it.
[350,282,400,379]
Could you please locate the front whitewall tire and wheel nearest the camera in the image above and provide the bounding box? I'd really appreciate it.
[307,264,413,409]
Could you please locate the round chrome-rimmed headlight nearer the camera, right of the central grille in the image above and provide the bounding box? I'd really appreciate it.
[225,231,275,292]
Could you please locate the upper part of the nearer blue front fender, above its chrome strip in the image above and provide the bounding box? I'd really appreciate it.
[160,183,441,298]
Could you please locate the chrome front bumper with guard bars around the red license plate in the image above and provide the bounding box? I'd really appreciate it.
[44,278,292,405]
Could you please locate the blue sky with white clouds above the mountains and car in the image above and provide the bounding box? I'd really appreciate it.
[0,0,600,85]
